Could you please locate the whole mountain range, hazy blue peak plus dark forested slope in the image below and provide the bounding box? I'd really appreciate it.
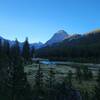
[0,30,100,62]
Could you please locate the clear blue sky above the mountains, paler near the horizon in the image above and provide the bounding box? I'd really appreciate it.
[0,0,100,43]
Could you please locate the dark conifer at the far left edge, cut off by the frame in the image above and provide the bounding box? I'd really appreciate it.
[0,40,10,100]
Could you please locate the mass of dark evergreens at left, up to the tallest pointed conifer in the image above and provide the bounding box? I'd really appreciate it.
[0,40,32,100]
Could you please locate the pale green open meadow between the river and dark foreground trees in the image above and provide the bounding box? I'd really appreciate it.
[25,63,100,96]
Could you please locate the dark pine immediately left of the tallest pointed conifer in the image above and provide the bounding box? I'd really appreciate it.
[10,40,31,100]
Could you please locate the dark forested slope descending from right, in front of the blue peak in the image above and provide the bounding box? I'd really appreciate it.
[36,30,100,61]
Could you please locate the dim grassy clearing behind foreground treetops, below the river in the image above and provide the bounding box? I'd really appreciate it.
[25,63,98,95]
